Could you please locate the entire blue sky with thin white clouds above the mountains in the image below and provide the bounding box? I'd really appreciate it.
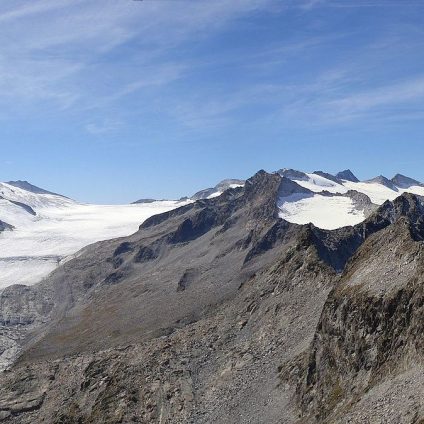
[0,0,424,203]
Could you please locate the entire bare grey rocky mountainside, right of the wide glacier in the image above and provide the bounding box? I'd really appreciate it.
[0,169,424,424]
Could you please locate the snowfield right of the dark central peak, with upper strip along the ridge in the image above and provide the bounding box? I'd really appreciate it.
[277,173,424,230]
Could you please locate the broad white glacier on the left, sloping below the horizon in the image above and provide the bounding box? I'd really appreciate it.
[0,183,187,288]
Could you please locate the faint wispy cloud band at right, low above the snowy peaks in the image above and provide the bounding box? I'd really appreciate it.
[276,71,424,126]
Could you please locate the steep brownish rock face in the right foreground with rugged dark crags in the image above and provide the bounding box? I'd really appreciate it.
[298,195,424,423]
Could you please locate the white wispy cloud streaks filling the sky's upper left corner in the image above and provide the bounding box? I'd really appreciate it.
[0,0,274,113]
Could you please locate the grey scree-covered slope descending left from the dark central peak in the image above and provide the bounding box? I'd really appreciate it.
[0,172,342,423]
